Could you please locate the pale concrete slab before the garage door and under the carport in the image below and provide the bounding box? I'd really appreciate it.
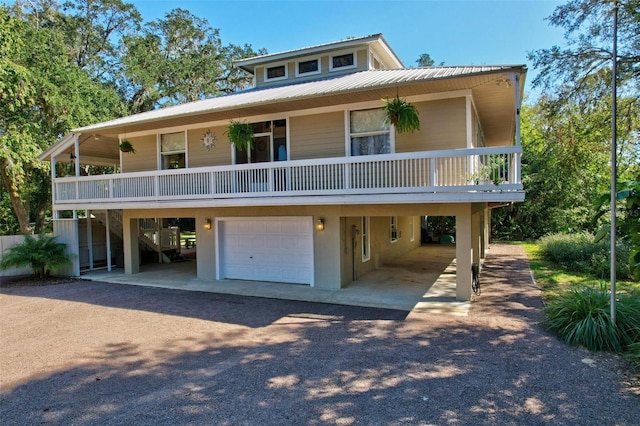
[81,245,470,316]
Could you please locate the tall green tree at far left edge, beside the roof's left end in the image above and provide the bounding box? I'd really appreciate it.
[0,7,122,233]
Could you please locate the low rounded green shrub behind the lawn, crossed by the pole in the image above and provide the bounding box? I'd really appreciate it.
[540,232,631,279]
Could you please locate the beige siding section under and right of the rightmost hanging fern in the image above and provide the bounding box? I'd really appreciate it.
[396,98,467,152]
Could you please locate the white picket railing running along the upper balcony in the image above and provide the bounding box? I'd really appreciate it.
[54,146,522,204]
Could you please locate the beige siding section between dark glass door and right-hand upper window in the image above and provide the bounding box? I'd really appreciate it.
[290,111,345,160]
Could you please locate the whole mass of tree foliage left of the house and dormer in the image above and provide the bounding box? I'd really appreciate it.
[0,0,265,233]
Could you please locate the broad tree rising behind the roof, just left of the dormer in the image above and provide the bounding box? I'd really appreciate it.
[123,9,264,113]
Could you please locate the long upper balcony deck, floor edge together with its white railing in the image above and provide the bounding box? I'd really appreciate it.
[53,146,524,210]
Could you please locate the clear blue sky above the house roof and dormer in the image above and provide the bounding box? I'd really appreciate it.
[133,0,564,81]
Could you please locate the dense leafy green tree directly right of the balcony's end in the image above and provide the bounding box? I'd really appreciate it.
[492,98,609,239]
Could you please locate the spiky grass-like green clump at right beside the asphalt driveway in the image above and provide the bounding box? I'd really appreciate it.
[542,285,640,352]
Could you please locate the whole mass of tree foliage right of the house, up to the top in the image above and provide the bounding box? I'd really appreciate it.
[493,0,640,243]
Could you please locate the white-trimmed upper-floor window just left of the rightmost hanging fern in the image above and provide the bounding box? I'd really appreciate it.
[349,108,391,156]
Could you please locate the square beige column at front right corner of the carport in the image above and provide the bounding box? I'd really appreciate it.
[456,204,473,300]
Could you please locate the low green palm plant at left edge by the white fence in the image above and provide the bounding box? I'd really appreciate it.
[0,234,71,278]
